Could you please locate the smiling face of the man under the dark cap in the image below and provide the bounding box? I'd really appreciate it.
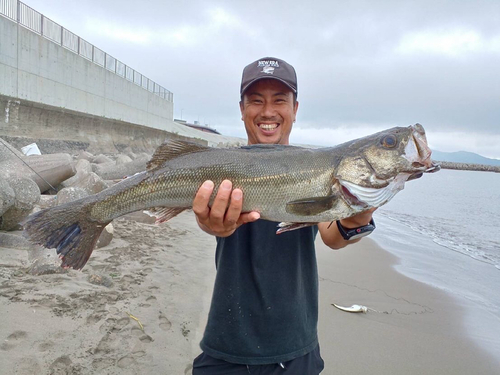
[240,79,299,145]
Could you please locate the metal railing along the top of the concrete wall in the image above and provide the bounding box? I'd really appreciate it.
[0,0,174,102]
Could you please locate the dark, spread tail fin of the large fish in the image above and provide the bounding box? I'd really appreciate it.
[22,201,109,270]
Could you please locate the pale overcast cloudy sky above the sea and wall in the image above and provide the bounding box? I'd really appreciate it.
[24,0,500,158]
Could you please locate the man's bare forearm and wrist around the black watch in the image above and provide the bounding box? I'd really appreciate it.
[318,208,376,250]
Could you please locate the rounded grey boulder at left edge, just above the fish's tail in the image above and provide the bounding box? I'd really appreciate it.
[0,176,40,231]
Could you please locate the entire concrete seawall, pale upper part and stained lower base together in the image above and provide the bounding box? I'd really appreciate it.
[0,16,245,152]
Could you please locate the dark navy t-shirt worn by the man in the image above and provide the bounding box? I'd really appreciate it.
[200,220,318,365]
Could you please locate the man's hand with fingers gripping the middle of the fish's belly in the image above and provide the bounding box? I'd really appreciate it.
[193,180,260,237]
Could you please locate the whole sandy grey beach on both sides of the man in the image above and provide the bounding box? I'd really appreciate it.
[0,212,500,375]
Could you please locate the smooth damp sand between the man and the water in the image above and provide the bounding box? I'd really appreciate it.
[317,238,499,375]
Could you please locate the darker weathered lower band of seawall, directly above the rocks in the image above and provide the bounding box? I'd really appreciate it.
[0,95,203,153]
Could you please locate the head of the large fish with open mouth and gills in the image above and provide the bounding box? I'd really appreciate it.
[336,124,440,208]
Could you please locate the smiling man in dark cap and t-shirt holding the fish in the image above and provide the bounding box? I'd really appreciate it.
[193,57,373,375]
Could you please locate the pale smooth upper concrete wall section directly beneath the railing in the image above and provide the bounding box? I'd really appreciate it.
[0,16,174,131]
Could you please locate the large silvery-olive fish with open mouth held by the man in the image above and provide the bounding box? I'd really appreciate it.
[23,124,439,269]
